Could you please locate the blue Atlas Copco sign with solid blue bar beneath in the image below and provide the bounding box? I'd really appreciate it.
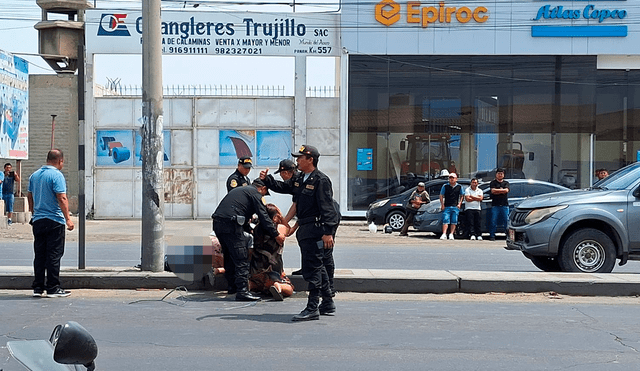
[531,0,628,37]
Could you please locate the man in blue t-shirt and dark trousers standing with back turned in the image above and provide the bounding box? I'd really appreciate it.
[27,149,74,297]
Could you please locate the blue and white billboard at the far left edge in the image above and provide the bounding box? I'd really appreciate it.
[0,50,29,160]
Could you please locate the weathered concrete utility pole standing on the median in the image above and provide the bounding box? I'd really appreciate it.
[141,0,164,272]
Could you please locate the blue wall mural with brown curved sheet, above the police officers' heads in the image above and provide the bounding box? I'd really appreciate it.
[220,130,292,167]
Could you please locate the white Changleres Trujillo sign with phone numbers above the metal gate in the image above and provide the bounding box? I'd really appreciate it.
[86,9,340,56]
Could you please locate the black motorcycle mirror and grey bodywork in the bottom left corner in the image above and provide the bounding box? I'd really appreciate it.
[0,321,98,371]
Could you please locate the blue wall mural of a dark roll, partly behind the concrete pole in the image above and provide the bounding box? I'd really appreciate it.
[96,130,171,167]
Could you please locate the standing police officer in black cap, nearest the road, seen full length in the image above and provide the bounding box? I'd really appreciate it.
[292,145,340,321]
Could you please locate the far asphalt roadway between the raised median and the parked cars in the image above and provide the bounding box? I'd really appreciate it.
[6,236,640,273]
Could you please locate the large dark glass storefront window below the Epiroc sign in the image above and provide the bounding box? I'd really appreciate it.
[347,55,640,210]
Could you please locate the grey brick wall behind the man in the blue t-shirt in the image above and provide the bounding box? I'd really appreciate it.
[23,75,78,213]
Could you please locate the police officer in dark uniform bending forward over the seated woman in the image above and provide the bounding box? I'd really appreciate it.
[211,179,285,301]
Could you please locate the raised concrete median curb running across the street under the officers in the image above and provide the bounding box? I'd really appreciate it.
[0,267,640,296]
